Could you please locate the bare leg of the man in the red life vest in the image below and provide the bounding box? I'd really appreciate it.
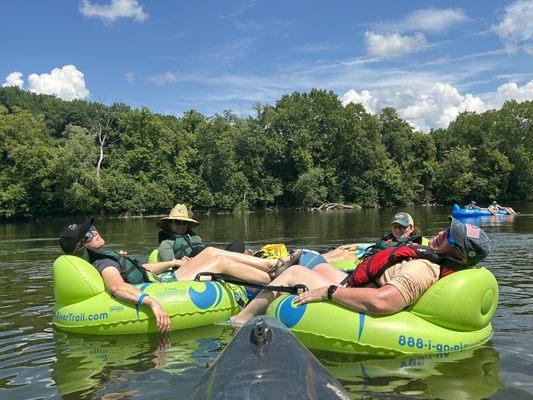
[234,264,346,324]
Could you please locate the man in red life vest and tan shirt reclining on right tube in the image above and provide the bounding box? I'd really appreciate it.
[233,218,490,325]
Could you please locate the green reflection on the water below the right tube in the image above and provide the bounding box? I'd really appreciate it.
[317,346,505,400]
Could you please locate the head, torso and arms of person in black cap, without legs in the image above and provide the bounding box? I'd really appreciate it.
[59,218,179,332]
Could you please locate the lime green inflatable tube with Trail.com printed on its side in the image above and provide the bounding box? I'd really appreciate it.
[53,256,246,335]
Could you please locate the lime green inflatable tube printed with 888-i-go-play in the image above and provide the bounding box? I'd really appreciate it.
[267,268,498,356]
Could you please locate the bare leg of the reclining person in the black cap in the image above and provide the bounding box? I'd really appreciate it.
[175,255,270,285]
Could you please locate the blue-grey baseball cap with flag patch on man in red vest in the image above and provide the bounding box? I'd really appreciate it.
[448,217,491,265]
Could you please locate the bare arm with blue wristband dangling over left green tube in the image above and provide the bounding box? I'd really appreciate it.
[102,263,170,332]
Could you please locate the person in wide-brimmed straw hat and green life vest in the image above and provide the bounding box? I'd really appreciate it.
[157,204,250,261]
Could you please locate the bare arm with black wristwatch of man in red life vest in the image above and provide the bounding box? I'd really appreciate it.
[294,285,407,315]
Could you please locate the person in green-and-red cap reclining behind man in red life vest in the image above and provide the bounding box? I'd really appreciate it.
[323,212,422,262]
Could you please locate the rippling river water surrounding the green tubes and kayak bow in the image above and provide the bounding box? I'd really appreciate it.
[0,204,533,400]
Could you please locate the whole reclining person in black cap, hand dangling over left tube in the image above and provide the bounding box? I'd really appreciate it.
[59,218,299,332]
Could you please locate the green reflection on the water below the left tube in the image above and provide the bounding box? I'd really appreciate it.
[52,325,233,399]
